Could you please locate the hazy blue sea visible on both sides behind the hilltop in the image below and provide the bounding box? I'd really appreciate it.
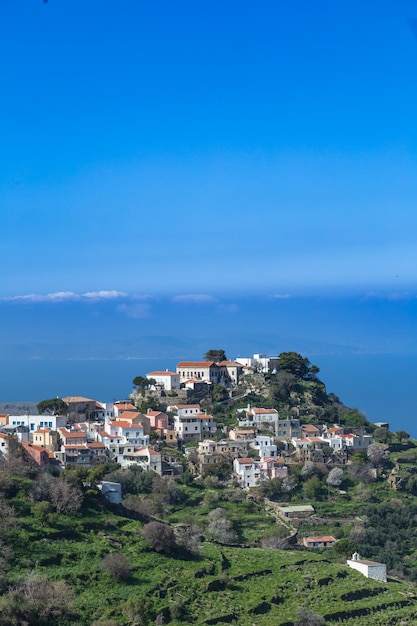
[0,354,417,438]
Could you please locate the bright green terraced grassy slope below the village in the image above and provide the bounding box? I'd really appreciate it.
[5,492,417,626]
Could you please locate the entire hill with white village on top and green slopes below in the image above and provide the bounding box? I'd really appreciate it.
[0,350,417,626]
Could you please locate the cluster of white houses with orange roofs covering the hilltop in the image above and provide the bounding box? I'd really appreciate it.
[0,351,373,489]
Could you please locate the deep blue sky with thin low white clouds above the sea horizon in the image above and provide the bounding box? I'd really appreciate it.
[0,0,417,354]
